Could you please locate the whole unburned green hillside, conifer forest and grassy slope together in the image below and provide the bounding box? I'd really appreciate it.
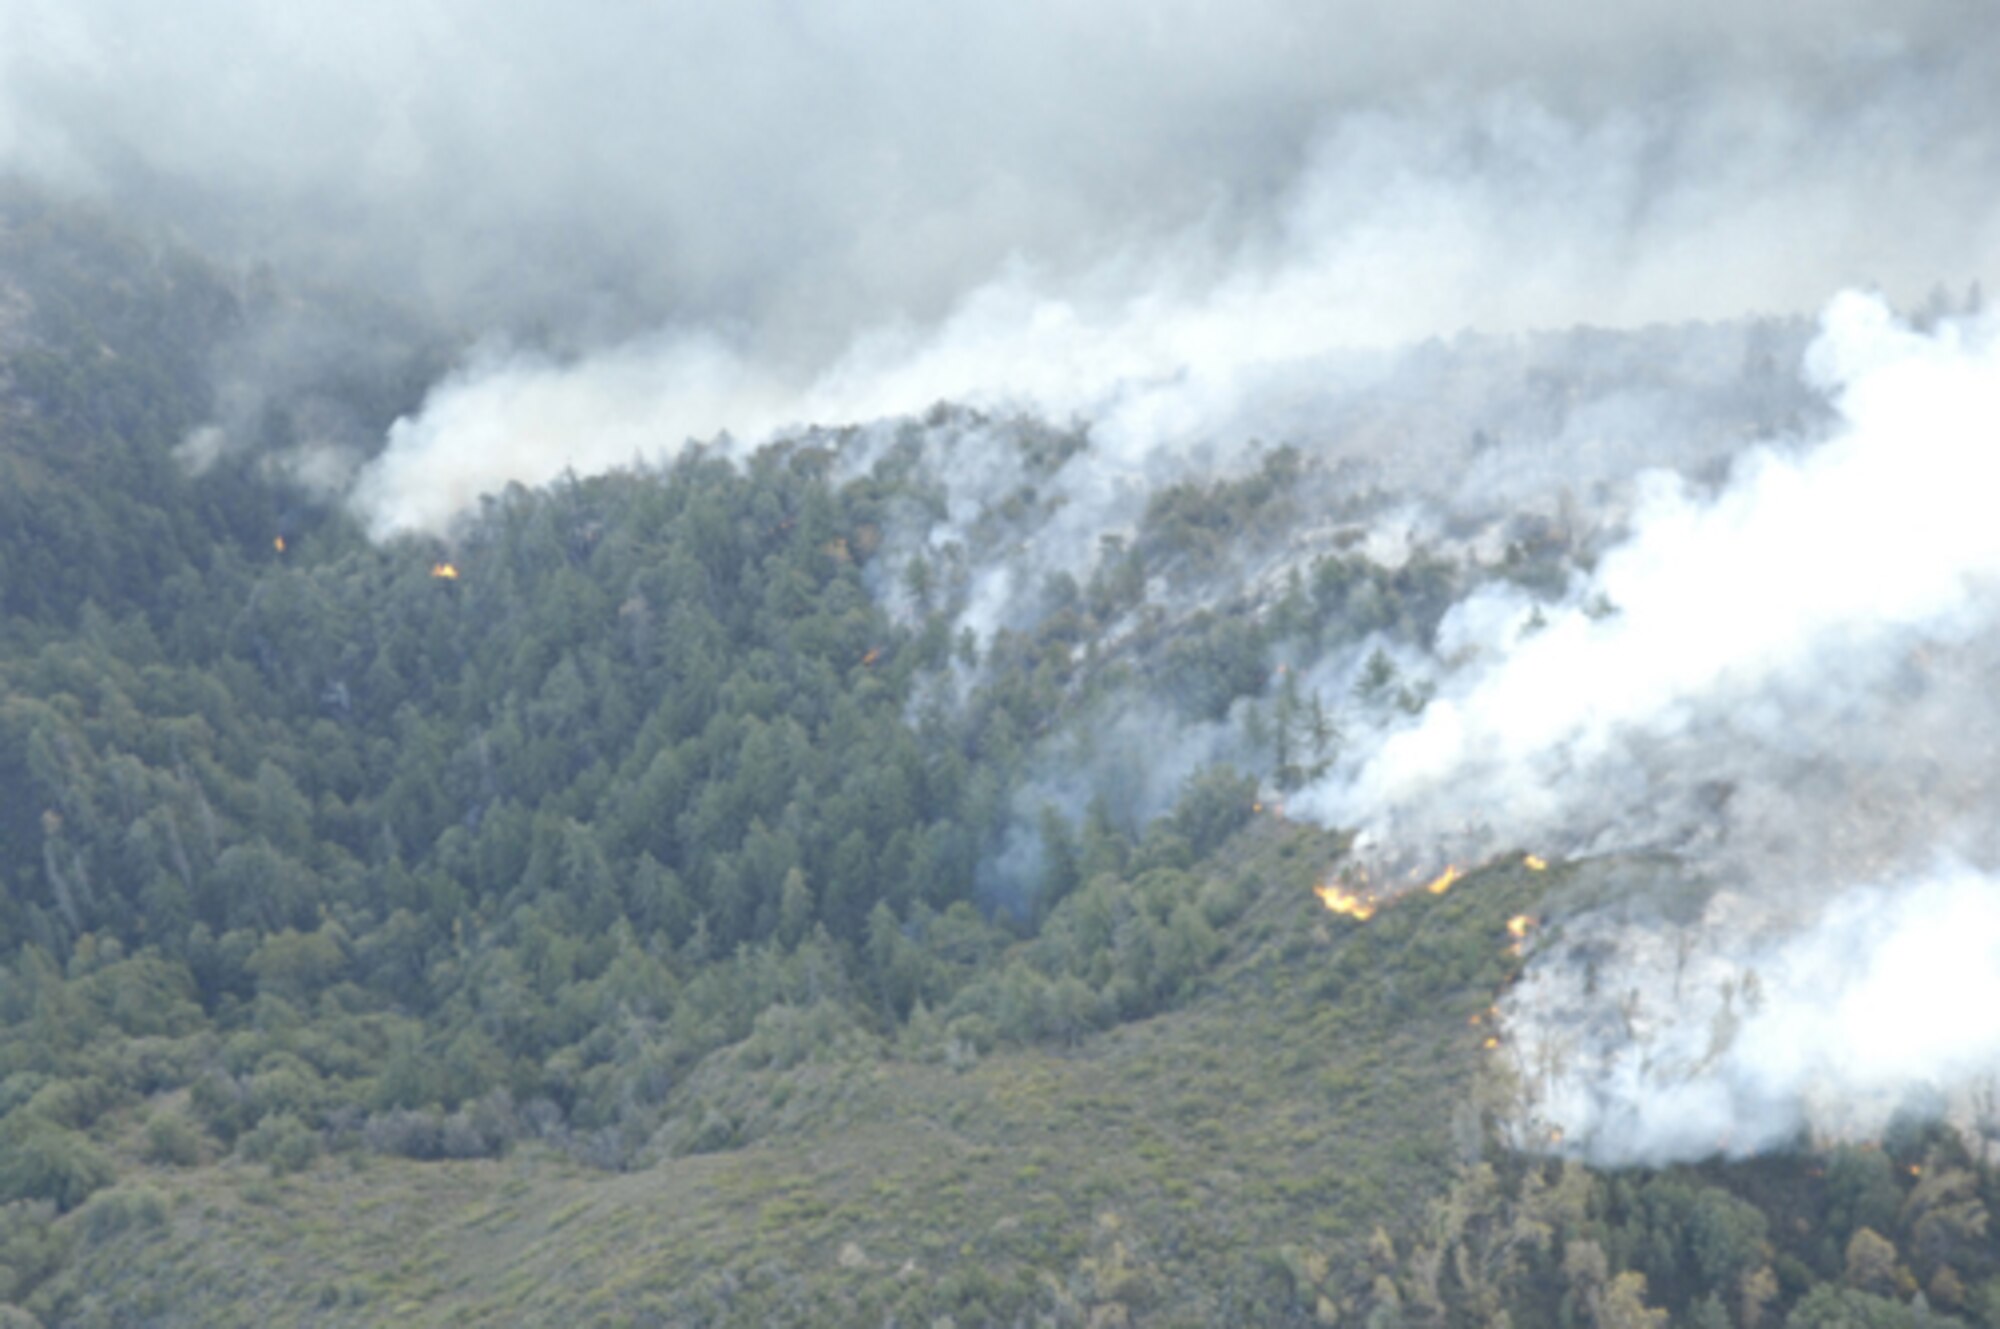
[0,186,2000,1327]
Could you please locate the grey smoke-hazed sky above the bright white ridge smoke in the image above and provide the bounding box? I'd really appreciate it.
[0,0,2000,364]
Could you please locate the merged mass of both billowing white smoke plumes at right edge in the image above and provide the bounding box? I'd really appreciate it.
[1292,294,2000,1163]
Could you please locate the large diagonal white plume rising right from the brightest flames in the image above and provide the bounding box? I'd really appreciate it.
[1312,294,2000,852]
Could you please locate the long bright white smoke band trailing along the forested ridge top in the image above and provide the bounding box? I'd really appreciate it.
[356,80,2000,532]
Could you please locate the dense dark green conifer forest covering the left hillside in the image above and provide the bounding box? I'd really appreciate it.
[0,262,1060,1185]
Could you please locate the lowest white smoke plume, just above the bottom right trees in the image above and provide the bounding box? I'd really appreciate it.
[1502,865,2000,1165]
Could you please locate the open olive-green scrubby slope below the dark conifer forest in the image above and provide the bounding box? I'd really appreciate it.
[44,825,1546,1325]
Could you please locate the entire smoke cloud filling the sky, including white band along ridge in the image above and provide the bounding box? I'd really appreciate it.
[11,0,2000,530]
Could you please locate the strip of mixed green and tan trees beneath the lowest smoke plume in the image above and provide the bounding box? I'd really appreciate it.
[1396,1123,2000,1329]
